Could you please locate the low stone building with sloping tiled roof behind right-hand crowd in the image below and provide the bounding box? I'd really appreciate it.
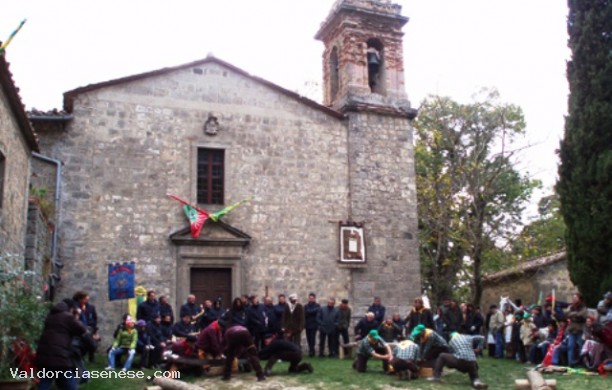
[482,252,578,307]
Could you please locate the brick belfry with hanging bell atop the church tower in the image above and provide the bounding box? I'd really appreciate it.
[315,0,411,114]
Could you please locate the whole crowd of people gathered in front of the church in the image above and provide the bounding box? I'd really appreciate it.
[37,290,612,389]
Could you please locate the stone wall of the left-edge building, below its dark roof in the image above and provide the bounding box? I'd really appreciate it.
[0,77,30,258]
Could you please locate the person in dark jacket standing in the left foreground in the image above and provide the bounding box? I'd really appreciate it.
[36,302,87,390]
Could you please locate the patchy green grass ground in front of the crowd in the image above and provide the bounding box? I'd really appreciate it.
[75,355,612,390]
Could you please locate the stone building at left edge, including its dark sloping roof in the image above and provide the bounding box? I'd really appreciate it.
[0,55,38,267]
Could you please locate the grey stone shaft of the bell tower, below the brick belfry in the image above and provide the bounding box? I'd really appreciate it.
[349,112,421,314]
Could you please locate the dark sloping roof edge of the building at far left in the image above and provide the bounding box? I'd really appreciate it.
[0,47,39,152]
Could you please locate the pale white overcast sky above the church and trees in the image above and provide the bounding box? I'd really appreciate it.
[0,0,570,213]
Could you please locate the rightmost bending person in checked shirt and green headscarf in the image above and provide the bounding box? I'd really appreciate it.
[427,332,488,389]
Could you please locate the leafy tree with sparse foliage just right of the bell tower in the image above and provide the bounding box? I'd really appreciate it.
[415,91,537,304]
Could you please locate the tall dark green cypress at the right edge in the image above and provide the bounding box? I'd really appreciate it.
[557,0,612,304]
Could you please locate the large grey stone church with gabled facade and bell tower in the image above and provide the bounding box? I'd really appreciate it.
[36,0,420,332]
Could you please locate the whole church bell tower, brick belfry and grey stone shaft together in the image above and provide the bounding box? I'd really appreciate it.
[316,0,421,315]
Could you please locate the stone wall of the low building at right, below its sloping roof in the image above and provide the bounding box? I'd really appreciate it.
[481,260,578,307]
